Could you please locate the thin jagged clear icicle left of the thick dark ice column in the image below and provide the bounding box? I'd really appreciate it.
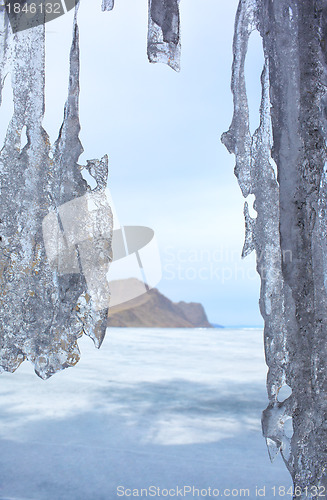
[222,0,288,478]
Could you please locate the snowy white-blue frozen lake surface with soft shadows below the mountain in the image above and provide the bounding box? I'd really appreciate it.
[0,328,292,500]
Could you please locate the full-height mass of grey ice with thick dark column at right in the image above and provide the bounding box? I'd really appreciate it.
[222,0,327,499]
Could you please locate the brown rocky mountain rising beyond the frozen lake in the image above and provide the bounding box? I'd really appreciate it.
[108,278,212,328]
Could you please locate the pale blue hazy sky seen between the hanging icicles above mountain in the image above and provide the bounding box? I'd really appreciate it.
[39,0,262,325]
